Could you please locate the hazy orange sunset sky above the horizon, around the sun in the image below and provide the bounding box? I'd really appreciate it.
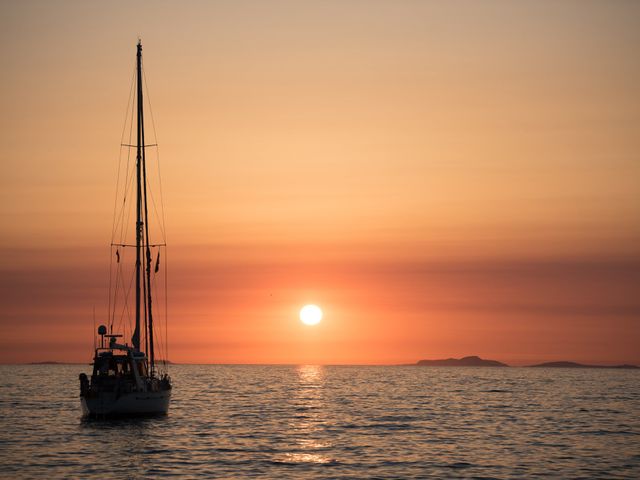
[0,0,640,365]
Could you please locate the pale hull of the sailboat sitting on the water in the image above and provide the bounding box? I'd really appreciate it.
[80,390,171,416]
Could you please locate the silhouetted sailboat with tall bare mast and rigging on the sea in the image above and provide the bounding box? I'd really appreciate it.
[80,41,172,416]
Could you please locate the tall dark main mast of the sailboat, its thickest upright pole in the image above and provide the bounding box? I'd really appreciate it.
[131,41,144,351]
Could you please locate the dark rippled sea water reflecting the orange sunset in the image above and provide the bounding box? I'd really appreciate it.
[0,365,640,479]
